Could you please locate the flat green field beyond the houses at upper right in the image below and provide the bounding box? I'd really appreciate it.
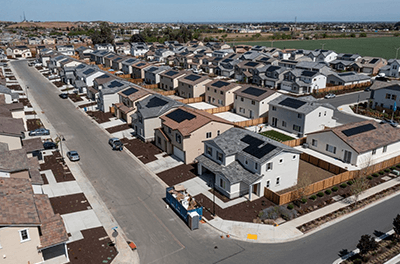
[230,37,400,59]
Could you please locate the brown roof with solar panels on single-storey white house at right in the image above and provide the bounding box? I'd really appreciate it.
[309,120,400,153]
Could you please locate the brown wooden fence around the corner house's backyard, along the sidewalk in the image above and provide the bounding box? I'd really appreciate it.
[264,153,400,205]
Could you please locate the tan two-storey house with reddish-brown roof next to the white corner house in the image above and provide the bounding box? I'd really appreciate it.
[155,106,233,164]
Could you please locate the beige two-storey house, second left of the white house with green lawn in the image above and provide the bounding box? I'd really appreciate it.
[205,80,241,107]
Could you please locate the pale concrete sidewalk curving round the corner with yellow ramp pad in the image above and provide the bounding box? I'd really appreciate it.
[208,175,400,243]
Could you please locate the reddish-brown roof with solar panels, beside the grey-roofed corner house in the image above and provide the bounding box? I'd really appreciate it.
[160,106,233,136]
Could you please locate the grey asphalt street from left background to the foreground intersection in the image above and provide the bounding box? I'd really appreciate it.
[12,61,400,264]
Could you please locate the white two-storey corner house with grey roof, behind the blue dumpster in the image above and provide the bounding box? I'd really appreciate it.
[196,127,301,200]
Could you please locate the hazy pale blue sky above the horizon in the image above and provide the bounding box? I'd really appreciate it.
[0,0,400,23]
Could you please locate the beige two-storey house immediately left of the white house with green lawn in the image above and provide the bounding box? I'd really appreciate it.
[233,85,279,119]
